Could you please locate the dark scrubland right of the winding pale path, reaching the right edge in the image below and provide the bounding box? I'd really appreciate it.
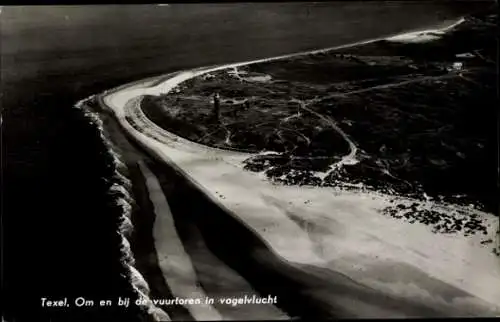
[315,8,498,213]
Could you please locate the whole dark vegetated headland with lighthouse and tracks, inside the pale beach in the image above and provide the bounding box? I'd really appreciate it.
[142,7,497,212]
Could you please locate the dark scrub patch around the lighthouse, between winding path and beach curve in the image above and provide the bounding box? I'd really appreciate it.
[141,89,347,156]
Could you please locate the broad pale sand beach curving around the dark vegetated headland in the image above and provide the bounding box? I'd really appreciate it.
[99,18,500,317]
